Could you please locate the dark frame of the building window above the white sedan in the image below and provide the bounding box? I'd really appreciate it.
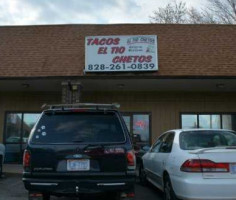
[179,112,236,129]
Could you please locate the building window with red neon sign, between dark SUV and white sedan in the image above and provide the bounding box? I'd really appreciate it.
[123,113,151,150]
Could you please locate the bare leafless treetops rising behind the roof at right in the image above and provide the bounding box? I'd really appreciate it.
[150,0,236,24]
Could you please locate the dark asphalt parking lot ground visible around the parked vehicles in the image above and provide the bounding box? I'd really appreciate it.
[0,174,162,200]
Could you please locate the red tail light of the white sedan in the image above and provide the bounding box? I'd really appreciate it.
[180,159,229,173]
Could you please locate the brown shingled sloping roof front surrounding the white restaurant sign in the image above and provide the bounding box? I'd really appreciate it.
[0,24,236,78]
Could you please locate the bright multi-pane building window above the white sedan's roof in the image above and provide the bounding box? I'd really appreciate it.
[181,113,236,131]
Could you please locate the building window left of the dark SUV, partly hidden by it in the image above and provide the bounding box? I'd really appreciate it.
[4,112,40,163]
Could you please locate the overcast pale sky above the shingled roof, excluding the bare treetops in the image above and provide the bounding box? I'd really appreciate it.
[0,0,206,25]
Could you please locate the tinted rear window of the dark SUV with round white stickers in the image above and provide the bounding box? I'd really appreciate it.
[32,112,125,144]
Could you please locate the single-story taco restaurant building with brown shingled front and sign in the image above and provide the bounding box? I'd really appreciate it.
[0,24,236,163]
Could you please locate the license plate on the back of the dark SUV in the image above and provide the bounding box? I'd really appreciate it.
[67,159,90,171]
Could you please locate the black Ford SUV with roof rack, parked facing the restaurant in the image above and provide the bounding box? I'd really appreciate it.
[23,104,136,200]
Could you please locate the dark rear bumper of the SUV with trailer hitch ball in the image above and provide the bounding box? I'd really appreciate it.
[23,177,135,195]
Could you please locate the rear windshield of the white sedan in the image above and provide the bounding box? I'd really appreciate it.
[180,130,236,150]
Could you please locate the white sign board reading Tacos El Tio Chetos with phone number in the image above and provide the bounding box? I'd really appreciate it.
[85,35,158,72]
